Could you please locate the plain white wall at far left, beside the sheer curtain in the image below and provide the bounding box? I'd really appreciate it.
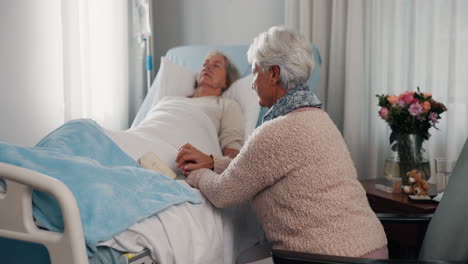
[0,0,64,146]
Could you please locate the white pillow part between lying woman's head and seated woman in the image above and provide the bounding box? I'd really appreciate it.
[223,74,260,140]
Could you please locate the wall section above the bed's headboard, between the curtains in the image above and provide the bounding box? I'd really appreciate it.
[153,0,284,69]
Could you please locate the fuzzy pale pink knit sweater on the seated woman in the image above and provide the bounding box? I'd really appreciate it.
[187,108,387,257]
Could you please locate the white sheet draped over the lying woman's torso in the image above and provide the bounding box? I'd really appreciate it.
[105,97,225,173]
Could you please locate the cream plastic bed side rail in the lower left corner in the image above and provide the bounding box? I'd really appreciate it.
[0,162,88,264]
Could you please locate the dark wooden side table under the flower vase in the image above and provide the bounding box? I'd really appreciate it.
[360,179,437,259]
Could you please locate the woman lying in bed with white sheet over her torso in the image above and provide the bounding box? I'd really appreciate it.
[106,51,244,175]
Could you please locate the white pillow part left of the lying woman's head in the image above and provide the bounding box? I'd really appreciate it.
[152,56,197,105]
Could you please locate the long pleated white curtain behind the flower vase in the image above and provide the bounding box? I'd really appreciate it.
[285,0,468,178]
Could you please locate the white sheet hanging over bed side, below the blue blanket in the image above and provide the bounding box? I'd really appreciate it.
[102,182,261,264]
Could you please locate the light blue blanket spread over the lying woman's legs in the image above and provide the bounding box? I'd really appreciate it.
[0,119,201,256]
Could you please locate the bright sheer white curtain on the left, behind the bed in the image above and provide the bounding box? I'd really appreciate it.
[62,0,129,130]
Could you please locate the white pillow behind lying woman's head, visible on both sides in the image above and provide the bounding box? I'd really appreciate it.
[152,56,260,139]
